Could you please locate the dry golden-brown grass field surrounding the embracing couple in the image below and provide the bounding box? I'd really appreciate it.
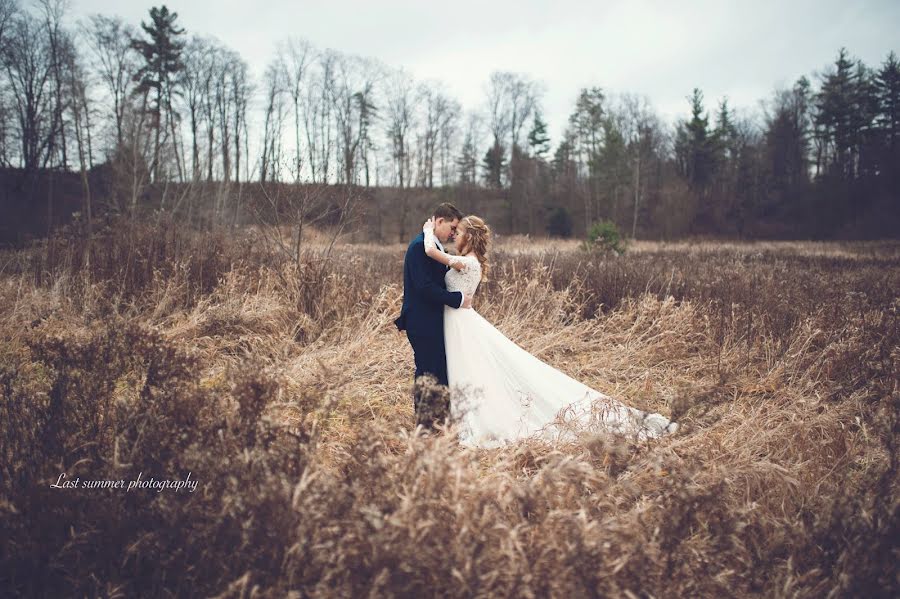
[0,218,900,597]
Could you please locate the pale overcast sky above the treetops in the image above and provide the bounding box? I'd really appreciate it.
[71,0,900,145]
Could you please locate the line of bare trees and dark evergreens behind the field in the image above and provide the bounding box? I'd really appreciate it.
[0,0,900,244]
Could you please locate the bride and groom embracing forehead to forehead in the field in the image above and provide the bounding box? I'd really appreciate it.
[395,203,678,447]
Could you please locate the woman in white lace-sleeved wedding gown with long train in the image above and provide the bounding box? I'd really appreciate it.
[422,215,678,447]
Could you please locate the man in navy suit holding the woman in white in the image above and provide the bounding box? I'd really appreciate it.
[394,203,472,428]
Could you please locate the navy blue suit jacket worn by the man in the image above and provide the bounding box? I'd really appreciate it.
[394,233,462,337]
